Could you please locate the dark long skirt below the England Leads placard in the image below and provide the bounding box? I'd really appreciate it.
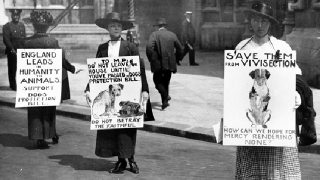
[28,106,56,140]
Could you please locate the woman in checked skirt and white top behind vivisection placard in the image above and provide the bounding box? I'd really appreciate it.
[235,2,301,179]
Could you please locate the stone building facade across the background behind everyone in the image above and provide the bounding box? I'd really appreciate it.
[0,0,320,88]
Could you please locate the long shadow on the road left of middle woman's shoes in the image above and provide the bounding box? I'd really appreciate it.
[49,155,115,171]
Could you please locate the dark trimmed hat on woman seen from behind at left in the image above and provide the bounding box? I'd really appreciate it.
[22,10,56,26]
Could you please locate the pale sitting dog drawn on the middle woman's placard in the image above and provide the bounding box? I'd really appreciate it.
[92,83,124,118]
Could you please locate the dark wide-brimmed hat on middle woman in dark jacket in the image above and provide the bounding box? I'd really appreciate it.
[95,12,133,30]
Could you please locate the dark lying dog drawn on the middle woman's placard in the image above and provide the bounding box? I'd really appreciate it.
[119,101,143,117]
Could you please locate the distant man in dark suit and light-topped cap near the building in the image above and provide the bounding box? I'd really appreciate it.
[181,11,199,66]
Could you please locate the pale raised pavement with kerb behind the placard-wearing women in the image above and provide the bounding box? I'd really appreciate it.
[0,48,320,144]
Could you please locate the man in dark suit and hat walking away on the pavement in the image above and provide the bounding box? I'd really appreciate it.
[146,18,183,109]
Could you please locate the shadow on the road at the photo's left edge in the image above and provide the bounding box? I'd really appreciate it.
[0,134,36,150]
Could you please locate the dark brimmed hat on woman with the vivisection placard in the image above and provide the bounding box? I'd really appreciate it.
[243,2,279,25]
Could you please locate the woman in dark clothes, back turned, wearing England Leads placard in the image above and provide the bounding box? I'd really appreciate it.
[23,11,82,148]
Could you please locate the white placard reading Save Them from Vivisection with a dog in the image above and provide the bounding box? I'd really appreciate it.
[223,50,297,147]
